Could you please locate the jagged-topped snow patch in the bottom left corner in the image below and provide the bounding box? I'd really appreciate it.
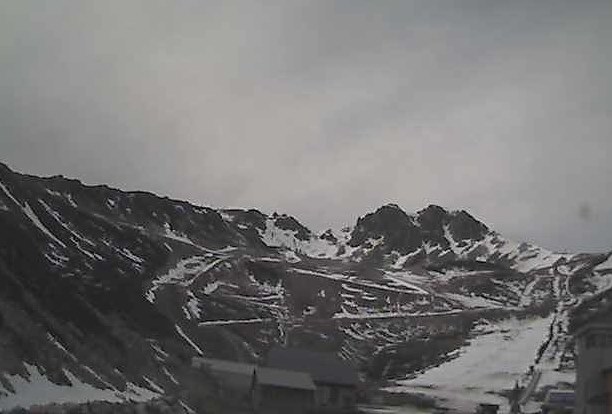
[0,364,159,410]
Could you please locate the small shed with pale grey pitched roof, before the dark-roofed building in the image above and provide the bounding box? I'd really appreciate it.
[253,367,316,414]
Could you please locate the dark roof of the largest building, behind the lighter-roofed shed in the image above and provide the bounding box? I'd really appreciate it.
[266,347,359,386]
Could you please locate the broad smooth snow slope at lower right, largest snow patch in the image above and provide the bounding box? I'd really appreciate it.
[387,318,551,410]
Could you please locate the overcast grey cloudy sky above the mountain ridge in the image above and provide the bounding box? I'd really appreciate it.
[0,0,612,250]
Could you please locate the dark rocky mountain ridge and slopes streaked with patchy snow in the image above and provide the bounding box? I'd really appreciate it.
[0,165,612,412]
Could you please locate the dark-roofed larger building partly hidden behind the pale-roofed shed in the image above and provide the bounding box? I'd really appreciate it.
[265,347,359,413]
